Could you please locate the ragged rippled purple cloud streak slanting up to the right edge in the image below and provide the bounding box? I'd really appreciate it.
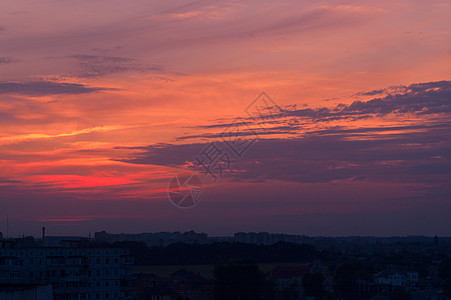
[182,81,451,140]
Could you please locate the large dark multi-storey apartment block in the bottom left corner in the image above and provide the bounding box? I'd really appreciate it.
[0,241,133,300]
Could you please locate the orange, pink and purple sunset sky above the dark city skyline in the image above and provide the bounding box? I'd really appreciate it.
[0,0,451,237]
